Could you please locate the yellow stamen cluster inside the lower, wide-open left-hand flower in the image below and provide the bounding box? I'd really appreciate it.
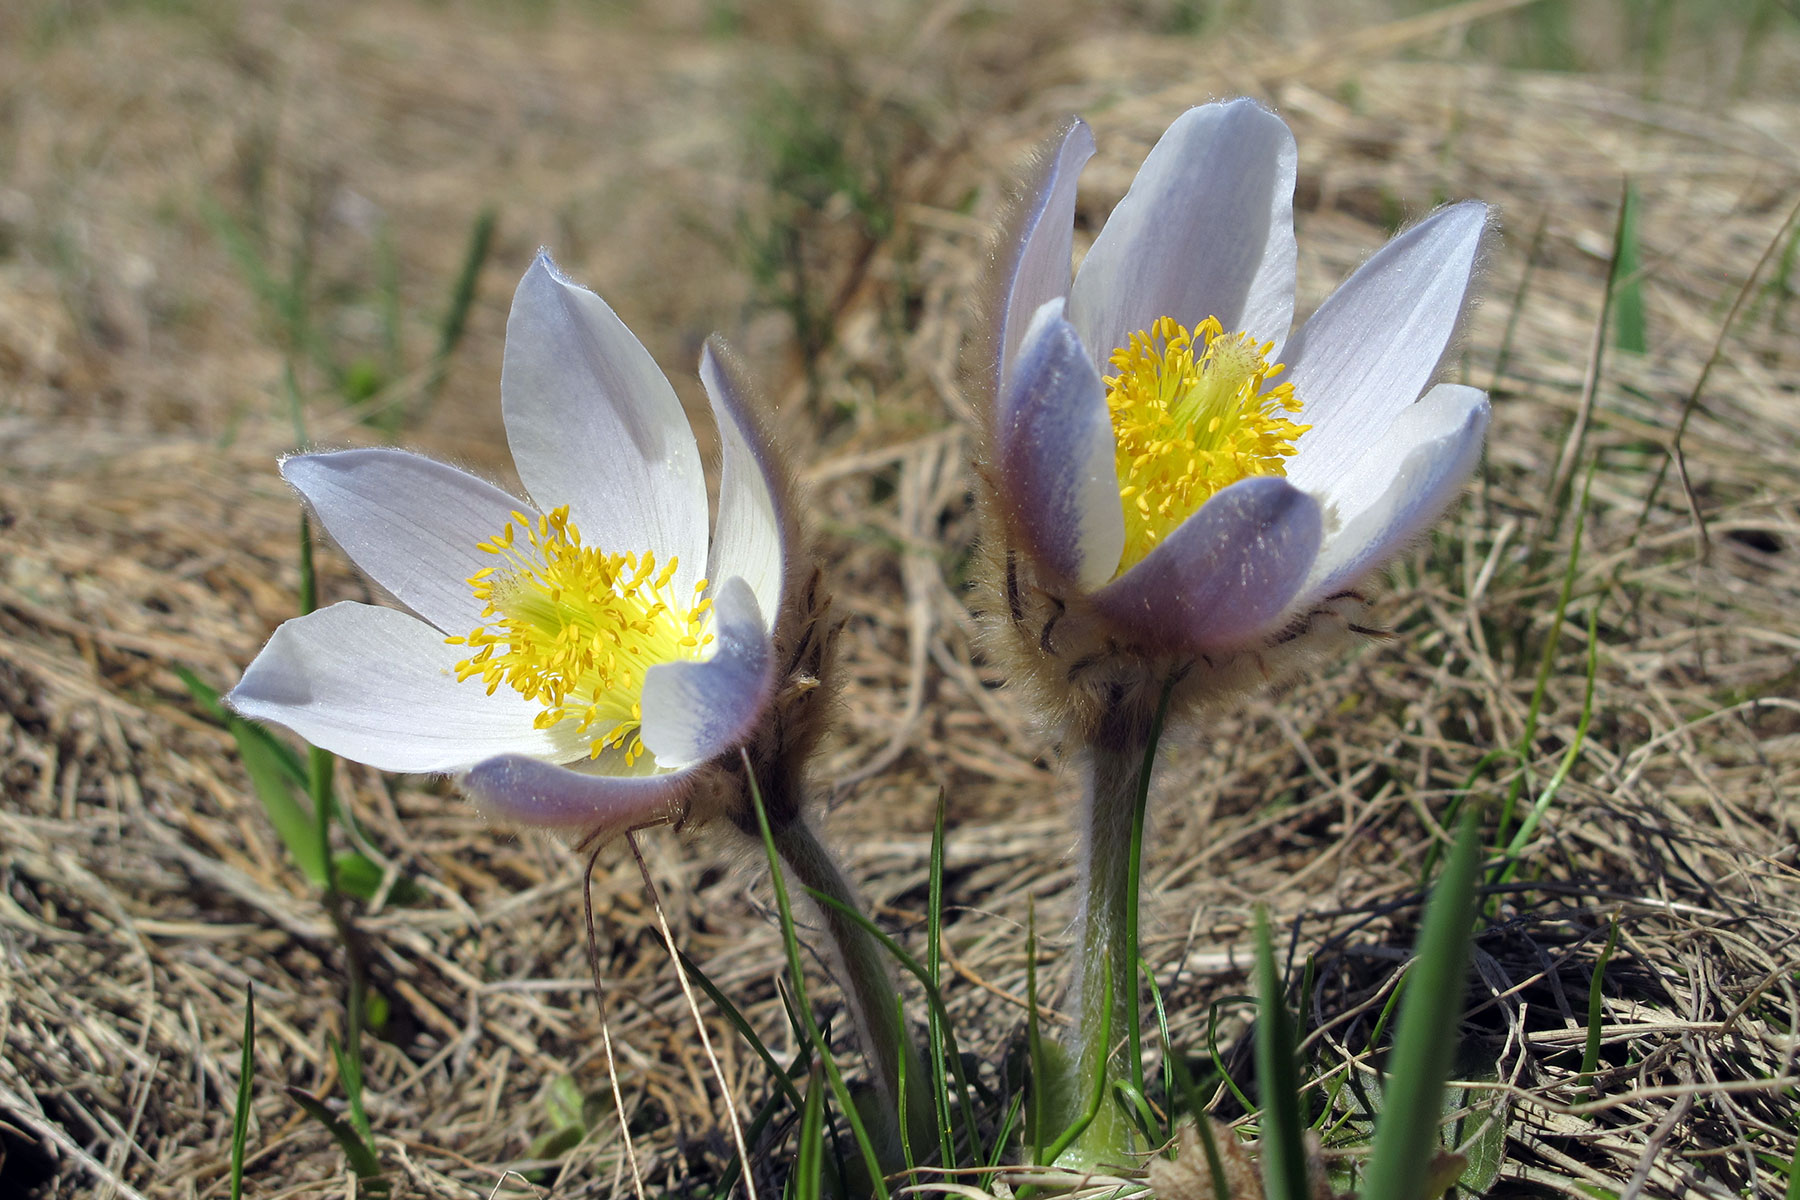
[445,506,713,766]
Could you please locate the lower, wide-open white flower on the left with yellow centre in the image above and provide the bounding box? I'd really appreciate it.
[227,254,794,833]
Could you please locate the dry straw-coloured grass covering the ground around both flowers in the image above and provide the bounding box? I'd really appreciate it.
[0,0,1800,1196]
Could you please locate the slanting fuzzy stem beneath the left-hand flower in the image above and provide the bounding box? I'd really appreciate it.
[772,815,938,1166]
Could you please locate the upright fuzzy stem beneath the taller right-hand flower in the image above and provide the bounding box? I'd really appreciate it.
[1058,693,1166,1168]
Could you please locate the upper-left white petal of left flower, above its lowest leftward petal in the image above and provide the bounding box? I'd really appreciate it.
[281,450,536,633]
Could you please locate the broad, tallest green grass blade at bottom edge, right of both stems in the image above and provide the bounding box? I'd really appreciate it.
[1363,808,1481,1200]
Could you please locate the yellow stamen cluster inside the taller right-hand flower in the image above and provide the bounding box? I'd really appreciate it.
[1105,317,1312,572]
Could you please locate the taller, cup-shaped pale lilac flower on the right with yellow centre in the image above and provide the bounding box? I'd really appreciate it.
[983,99,1489,655]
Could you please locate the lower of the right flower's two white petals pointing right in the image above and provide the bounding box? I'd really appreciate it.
[1305,383,1489,599]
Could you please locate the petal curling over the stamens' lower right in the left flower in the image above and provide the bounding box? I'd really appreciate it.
[641,579,774,766]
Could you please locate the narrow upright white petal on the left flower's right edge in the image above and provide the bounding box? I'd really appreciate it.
[700,338,796,630]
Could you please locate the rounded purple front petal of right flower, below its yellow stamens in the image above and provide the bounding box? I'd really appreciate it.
[1094,475,1323,651]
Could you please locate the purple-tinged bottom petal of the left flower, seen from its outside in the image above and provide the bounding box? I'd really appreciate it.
[457,754,695,840]
